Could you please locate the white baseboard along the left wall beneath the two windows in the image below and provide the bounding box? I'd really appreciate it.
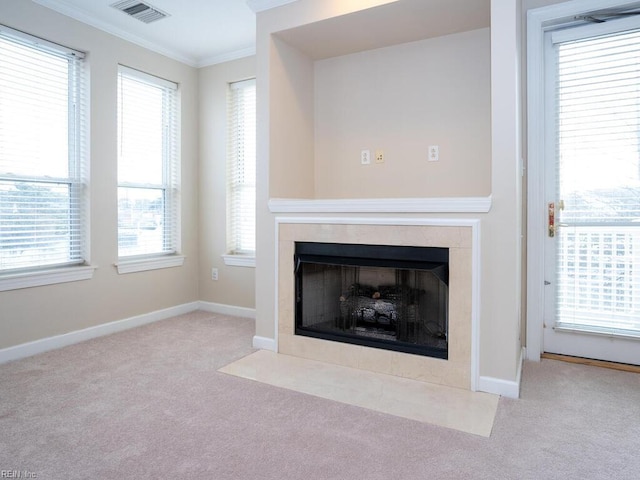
[0,302,199,363]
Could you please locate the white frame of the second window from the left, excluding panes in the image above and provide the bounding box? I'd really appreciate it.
[115,65,185,274]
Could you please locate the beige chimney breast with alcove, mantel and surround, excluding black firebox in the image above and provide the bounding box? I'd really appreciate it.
[254,0,522,396]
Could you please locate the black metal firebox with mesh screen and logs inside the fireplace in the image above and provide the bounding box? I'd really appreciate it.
[294,242,449,359]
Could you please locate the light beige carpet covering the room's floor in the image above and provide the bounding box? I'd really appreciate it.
[0,312,640,480]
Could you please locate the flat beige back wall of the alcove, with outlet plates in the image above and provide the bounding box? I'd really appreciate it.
[315,28,491,198]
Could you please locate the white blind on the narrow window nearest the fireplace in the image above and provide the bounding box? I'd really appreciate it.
[227,80,256,255]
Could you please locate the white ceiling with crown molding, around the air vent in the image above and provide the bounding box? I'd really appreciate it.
[33,0,256,67]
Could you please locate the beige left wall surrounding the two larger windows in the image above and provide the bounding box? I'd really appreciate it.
[0,0,199,348]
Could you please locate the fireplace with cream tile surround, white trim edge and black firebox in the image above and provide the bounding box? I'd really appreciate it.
[274,220,479,389]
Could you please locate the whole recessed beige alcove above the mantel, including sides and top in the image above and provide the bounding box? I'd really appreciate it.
[269,0,491,200]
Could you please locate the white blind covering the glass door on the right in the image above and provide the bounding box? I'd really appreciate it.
[553,22,640,335]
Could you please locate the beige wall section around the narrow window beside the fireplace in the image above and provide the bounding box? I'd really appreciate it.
[198,56,256,308]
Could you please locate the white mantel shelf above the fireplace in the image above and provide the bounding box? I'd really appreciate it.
[269,196,491,213]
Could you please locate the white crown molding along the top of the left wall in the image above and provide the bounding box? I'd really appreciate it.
[33,0,198,67]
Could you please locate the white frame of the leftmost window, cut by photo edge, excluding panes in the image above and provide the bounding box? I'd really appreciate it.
[0,25,96,291]
